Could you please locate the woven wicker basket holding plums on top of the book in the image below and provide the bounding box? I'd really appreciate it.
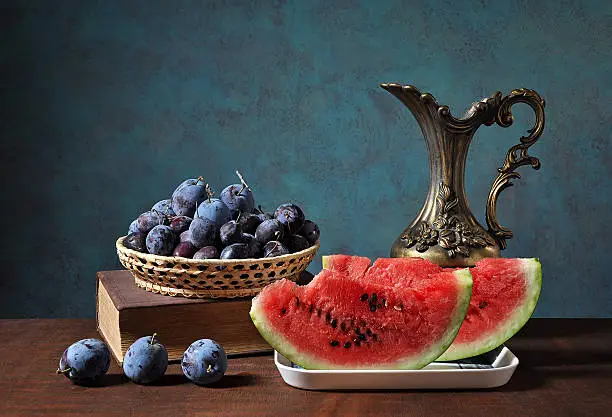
[116,236,319,298]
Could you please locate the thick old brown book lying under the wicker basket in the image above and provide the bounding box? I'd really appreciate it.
[96,270,280,364]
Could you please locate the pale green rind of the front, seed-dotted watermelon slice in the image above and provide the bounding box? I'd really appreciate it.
[249,268,472,370]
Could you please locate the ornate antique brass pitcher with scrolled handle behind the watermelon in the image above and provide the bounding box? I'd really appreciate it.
[381,83,544,267]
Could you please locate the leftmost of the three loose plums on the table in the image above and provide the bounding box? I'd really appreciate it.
[57,339,110,385]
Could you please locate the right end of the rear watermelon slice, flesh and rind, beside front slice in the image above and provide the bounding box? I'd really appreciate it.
[438,258,542,361]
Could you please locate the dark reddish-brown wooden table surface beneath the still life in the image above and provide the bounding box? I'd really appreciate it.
[0,319,612,417]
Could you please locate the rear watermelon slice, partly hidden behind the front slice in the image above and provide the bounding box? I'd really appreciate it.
[324,255,542,361]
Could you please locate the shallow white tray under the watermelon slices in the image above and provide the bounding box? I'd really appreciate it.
[274,347,519,390]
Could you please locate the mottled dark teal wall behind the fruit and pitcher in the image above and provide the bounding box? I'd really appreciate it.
[0,0,612,317]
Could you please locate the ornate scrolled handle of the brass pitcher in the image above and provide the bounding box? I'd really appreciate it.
[486,88,545,249]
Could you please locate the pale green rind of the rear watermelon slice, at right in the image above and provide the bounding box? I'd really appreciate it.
[436,258,542,362]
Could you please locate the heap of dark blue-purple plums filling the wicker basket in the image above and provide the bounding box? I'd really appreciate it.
[123,171,319,259]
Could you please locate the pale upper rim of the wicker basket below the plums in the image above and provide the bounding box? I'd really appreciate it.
[115,236,321,265]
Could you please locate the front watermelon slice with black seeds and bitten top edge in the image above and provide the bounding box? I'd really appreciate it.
[250,269,472,369]
